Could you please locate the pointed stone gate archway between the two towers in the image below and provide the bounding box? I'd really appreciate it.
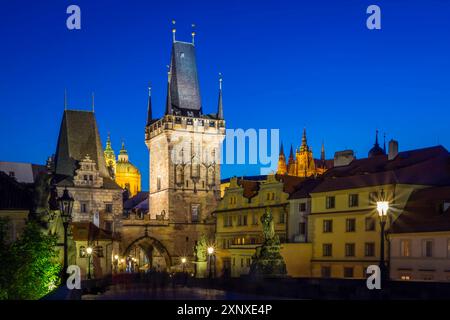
[122,235,172,271]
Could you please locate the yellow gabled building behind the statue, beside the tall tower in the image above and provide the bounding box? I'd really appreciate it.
[215,175,311,277]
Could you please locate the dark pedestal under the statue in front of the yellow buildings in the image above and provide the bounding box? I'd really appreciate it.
[250,239,287,277]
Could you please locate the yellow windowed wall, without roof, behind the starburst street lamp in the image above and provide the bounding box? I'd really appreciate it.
[309,185,419,278]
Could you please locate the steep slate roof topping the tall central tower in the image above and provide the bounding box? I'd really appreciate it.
[170,41,202,116]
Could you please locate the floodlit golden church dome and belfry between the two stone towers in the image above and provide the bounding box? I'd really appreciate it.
[104,135,141,197]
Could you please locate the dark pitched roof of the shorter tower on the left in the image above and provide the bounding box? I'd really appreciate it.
[55,110,109,178]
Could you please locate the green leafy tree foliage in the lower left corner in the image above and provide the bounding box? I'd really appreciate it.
[0,220,61,300]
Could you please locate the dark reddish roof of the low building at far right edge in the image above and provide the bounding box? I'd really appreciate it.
[390,186,450,233]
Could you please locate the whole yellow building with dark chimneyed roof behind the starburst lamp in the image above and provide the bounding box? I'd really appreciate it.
[308,139,448,278]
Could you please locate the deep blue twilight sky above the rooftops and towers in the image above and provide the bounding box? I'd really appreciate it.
[0,0,450,189]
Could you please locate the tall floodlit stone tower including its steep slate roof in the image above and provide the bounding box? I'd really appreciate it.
[137,35,225,267]
